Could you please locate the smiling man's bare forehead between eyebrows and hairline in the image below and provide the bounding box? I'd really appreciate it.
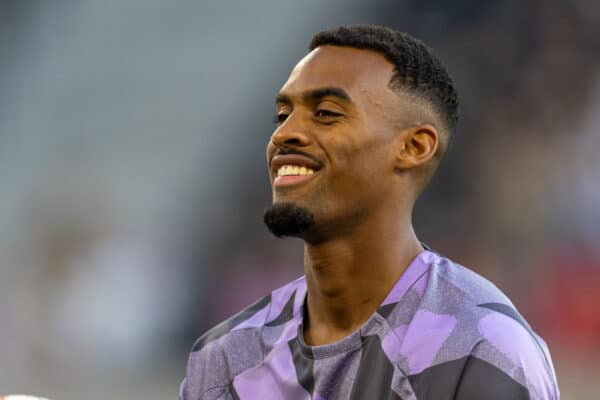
[281,46,394,98]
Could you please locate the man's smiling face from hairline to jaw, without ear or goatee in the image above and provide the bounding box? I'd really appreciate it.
[267,46,399,241]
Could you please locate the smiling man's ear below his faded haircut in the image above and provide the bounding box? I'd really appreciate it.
[395,124,440,170]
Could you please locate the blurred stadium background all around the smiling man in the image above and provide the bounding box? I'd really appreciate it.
[0,0,600,400]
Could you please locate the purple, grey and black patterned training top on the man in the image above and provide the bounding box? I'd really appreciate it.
[180,250,559,400]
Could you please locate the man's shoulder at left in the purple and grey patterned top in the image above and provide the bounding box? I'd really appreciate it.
[180,277,306,400]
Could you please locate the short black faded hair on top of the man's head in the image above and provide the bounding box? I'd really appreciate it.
[309,25,458,137]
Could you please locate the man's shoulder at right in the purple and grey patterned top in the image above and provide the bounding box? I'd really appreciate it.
[409,256,558,399]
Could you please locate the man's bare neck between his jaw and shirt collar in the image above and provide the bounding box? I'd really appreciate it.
[304,209,423,345]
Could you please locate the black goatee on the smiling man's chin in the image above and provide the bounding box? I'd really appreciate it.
[263,203,315,238]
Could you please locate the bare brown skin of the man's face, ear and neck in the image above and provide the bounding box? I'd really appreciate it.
[267,46,440,345]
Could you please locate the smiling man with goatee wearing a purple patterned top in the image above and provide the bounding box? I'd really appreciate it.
[181,26,559,400]
